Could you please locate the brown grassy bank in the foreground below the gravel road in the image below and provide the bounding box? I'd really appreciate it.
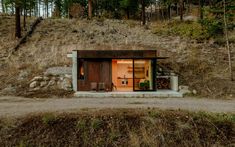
[0,109,235,146]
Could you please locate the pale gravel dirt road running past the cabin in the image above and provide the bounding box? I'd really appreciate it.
[0,96,235,117]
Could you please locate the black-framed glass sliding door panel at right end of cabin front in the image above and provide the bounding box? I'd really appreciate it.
[133,59,154,91]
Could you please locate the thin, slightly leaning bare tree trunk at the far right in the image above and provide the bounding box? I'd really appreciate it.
[223,0,233,81]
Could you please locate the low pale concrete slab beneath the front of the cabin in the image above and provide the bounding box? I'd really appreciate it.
[74,90,183,98]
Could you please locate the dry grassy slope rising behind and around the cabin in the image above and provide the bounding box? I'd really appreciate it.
[0,17,235,97]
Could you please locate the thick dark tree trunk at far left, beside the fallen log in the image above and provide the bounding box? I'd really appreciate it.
[15,1,21,38]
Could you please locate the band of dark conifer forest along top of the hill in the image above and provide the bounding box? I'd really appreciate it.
[1,0,235,39]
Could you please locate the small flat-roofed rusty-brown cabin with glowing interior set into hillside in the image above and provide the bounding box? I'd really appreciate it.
[68,50,178,92]
